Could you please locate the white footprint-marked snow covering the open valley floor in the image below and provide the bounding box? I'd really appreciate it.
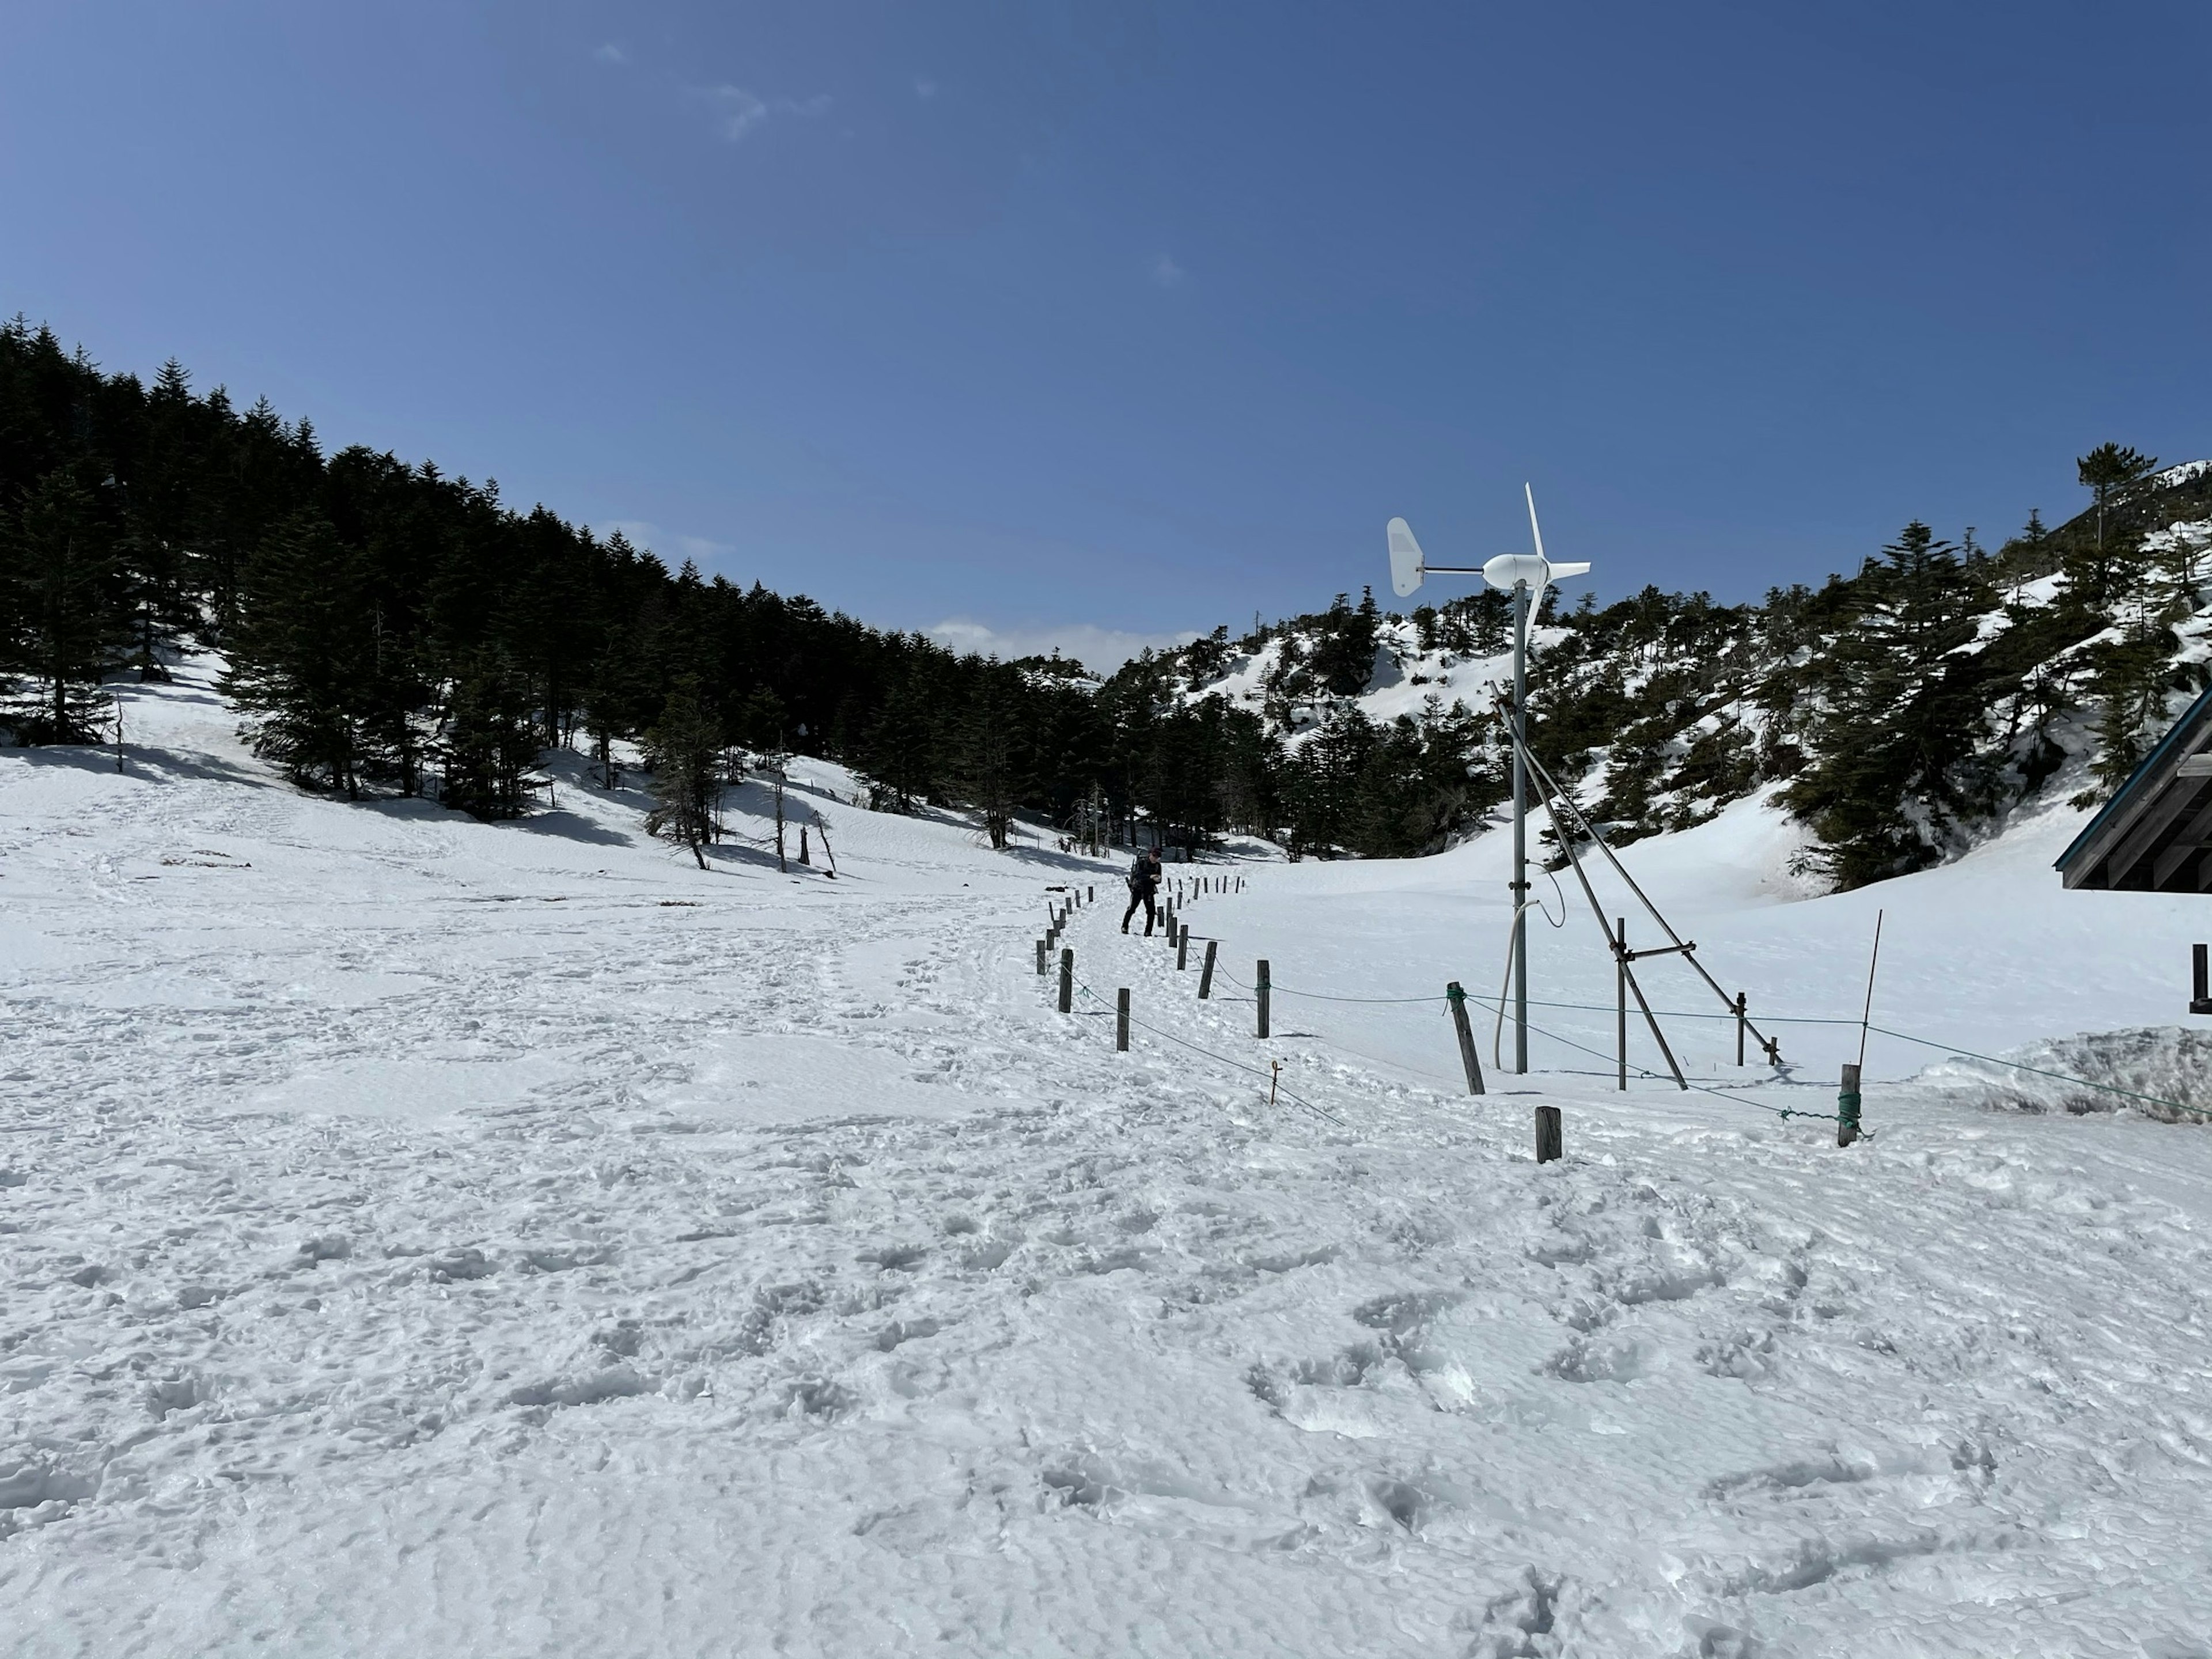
[0,677,2212,1659]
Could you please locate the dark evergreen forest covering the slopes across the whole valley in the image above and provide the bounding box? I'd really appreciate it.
[0,319,2212,887]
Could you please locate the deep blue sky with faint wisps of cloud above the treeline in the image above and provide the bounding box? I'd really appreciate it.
[0,0,2212,657]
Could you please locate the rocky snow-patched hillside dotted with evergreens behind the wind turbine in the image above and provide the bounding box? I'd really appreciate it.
[1159,473,2212,887]
